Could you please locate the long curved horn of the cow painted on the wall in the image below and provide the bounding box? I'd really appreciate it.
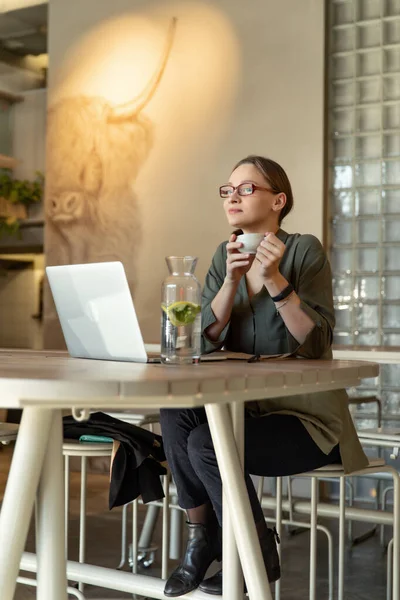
[107,17,177,123]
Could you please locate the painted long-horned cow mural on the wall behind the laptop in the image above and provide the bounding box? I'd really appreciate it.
[45,18,177,347]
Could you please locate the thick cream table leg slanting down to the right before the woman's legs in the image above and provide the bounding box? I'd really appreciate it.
[205,403,272,600]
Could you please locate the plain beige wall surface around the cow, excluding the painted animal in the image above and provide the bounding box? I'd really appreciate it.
[47,0,324,341]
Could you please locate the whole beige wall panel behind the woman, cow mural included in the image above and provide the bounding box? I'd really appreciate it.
[45,0,324,346]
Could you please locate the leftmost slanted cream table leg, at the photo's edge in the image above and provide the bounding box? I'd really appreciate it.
[0,408,53,600]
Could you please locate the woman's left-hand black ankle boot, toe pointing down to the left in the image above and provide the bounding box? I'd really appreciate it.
[164,523,221,598]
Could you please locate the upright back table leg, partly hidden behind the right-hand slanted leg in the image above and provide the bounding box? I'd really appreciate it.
[222,403,244,600]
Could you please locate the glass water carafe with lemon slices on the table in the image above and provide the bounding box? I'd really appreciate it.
[161,256,201,365]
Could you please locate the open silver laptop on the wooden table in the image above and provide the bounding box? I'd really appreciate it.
[46,262,227,363]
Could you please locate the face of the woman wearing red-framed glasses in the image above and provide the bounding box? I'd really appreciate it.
[220,163,279,233]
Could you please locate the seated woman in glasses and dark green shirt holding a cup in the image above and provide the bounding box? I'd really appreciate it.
[161,156,367,597]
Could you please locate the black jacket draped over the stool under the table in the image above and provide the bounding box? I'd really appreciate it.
[63,412,167,510]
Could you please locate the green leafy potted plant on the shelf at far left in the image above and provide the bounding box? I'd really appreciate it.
[0,169,44,237]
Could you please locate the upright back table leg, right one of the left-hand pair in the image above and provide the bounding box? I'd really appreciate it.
[36,410,67,600]
